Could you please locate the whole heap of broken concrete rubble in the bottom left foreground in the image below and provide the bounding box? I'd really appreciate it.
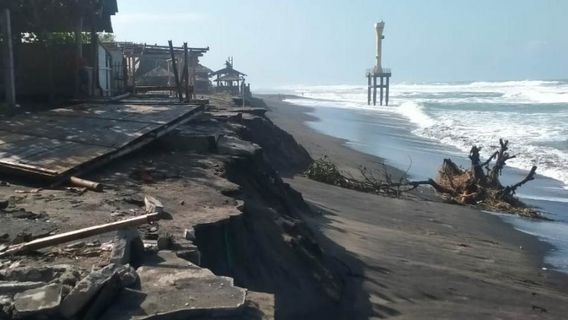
[0,208,246,319]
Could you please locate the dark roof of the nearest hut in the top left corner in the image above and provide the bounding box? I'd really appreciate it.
[9,0,118,32]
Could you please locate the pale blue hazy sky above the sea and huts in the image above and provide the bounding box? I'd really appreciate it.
[113,0,568,88]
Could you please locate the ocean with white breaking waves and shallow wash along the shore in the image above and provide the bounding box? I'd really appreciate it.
[274,81,568,272]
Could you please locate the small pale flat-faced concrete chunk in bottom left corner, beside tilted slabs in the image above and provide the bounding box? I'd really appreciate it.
[14,283,63,318]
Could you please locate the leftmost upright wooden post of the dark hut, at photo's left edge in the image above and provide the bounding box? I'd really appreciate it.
[1,8,16,107]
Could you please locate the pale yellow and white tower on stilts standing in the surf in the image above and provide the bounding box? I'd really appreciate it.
[367,21,391,106]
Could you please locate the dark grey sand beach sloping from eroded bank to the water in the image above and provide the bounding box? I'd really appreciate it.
[263,96,568,319]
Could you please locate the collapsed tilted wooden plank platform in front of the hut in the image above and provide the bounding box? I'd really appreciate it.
[0,100,202,183]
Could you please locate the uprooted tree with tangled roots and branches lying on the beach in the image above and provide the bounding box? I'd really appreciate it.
[305,139,543,218]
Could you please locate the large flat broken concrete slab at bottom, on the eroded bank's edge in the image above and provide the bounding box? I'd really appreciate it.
[102,251,246,320]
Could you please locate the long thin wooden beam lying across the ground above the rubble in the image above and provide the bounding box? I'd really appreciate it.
[0,213,159,257]
